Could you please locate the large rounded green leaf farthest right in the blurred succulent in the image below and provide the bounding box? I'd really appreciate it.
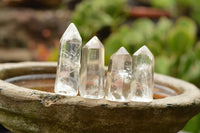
[167,17,197,55]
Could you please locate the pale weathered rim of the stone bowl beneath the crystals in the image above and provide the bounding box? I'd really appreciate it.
[0,62,200,109]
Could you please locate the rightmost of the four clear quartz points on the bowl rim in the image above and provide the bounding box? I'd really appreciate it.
[131,46,154,102]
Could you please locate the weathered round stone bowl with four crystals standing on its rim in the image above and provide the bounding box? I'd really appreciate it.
[0,62,200,133]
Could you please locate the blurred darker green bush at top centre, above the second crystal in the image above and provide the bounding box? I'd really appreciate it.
[72,0,126,41]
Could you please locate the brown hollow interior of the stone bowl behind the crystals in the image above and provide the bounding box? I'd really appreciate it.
[5,73,178,99]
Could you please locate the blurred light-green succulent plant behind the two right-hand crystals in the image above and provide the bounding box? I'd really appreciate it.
[104,17,200,86]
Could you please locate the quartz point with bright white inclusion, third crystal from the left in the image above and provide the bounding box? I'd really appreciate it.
[105,47,132,102]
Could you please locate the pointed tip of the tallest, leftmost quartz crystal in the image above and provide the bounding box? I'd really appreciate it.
[60,23,82,42]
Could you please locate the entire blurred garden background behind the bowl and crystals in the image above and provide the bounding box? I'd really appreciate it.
[0,0,200,133]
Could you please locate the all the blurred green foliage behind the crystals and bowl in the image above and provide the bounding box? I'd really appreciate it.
[71,0,200,133]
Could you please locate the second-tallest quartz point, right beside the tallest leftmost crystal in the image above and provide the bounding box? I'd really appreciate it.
[79,36,104,99]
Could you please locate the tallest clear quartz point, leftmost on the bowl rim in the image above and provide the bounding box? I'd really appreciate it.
[54,23,82,96]
